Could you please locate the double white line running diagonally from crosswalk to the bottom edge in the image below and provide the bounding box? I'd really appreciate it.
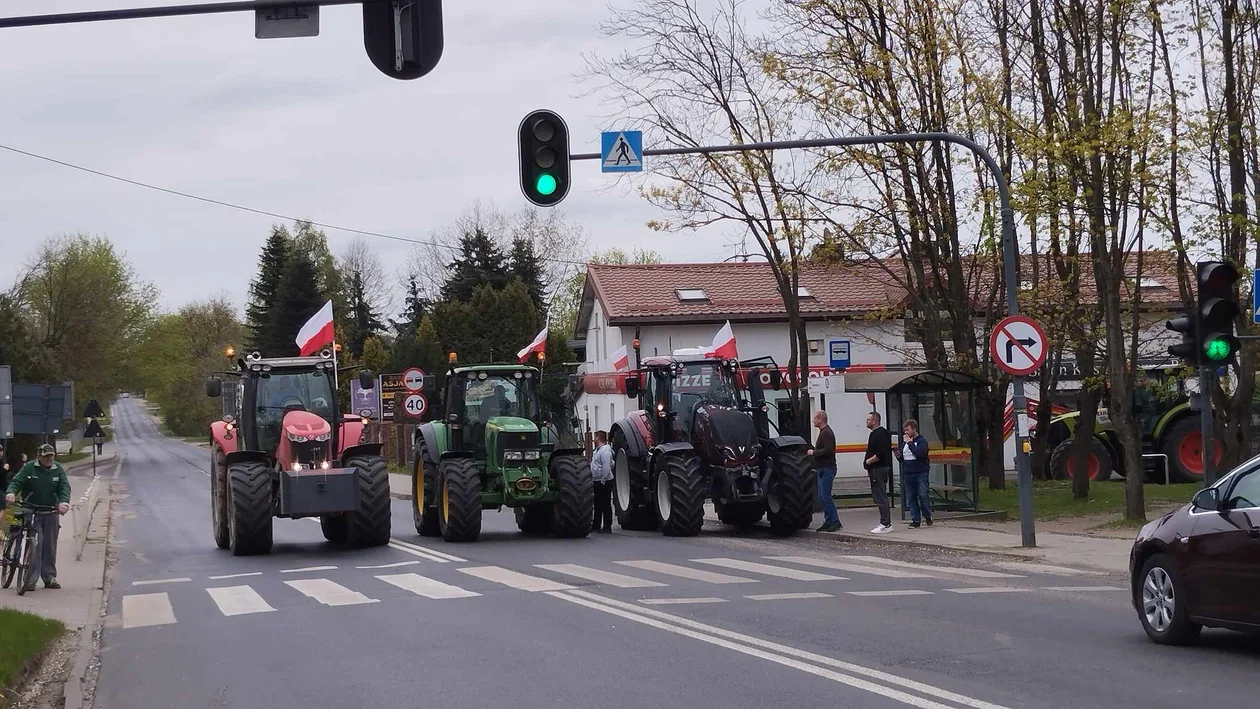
[548,591,1007,709]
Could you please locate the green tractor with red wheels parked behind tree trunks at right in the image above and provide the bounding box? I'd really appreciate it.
[1050,366,1220,482]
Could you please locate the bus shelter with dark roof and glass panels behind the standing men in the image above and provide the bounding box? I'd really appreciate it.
[844,369,988,519]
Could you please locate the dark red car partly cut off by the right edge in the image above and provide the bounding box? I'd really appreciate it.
[1129,456,1260,645]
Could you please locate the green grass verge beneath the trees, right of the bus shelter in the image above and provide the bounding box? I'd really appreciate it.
[980,480,1202,520]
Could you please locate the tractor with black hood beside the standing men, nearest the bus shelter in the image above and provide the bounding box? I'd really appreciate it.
[610,350,815,536]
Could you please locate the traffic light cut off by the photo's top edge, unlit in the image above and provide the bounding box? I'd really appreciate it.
[363,0,442,79]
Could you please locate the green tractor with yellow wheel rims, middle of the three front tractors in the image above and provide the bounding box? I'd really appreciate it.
[412,355,595,542]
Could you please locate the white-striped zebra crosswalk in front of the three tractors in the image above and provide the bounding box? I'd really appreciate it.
[117,555,1125,630]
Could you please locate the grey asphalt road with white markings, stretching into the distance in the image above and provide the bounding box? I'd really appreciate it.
[96,399,1260,709]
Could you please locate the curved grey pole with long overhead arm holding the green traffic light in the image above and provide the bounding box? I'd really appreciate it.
[570,132,1037,547]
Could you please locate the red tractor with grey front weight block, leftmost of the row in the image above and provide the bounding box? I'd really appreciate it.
[205,350,391,555]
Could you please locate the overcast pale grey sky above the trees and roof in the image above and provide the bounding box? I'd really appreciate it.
[0,0,733,307]
